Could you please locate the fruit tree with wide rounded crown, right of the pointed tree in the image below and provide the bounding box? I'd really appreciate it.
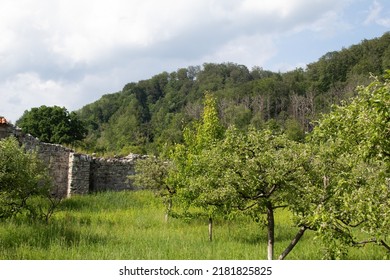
[193,127,314,259]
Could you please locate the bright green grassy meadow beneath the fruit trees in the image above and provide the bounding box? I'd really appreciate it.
[0,191,386,260]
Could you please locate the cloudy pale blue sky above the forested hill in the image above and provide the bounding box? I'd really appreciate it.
[0,0,390,123]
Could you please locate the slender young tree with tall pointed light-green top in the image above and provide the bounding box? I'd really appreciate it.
[168,92,224,241]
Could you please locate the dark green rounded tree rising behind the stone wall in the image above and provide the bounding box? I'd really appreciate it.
[16,106,86,144]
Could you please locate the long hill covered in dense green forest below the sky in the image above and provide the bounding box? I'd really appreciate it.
[78,33,390,155]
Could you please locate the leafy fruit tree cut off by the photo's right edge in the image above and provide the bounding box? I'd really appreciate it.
[310,71,390,258]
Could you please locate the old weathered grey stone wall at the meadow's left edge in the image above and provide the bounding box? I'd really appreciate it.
[0,121,140,197]
